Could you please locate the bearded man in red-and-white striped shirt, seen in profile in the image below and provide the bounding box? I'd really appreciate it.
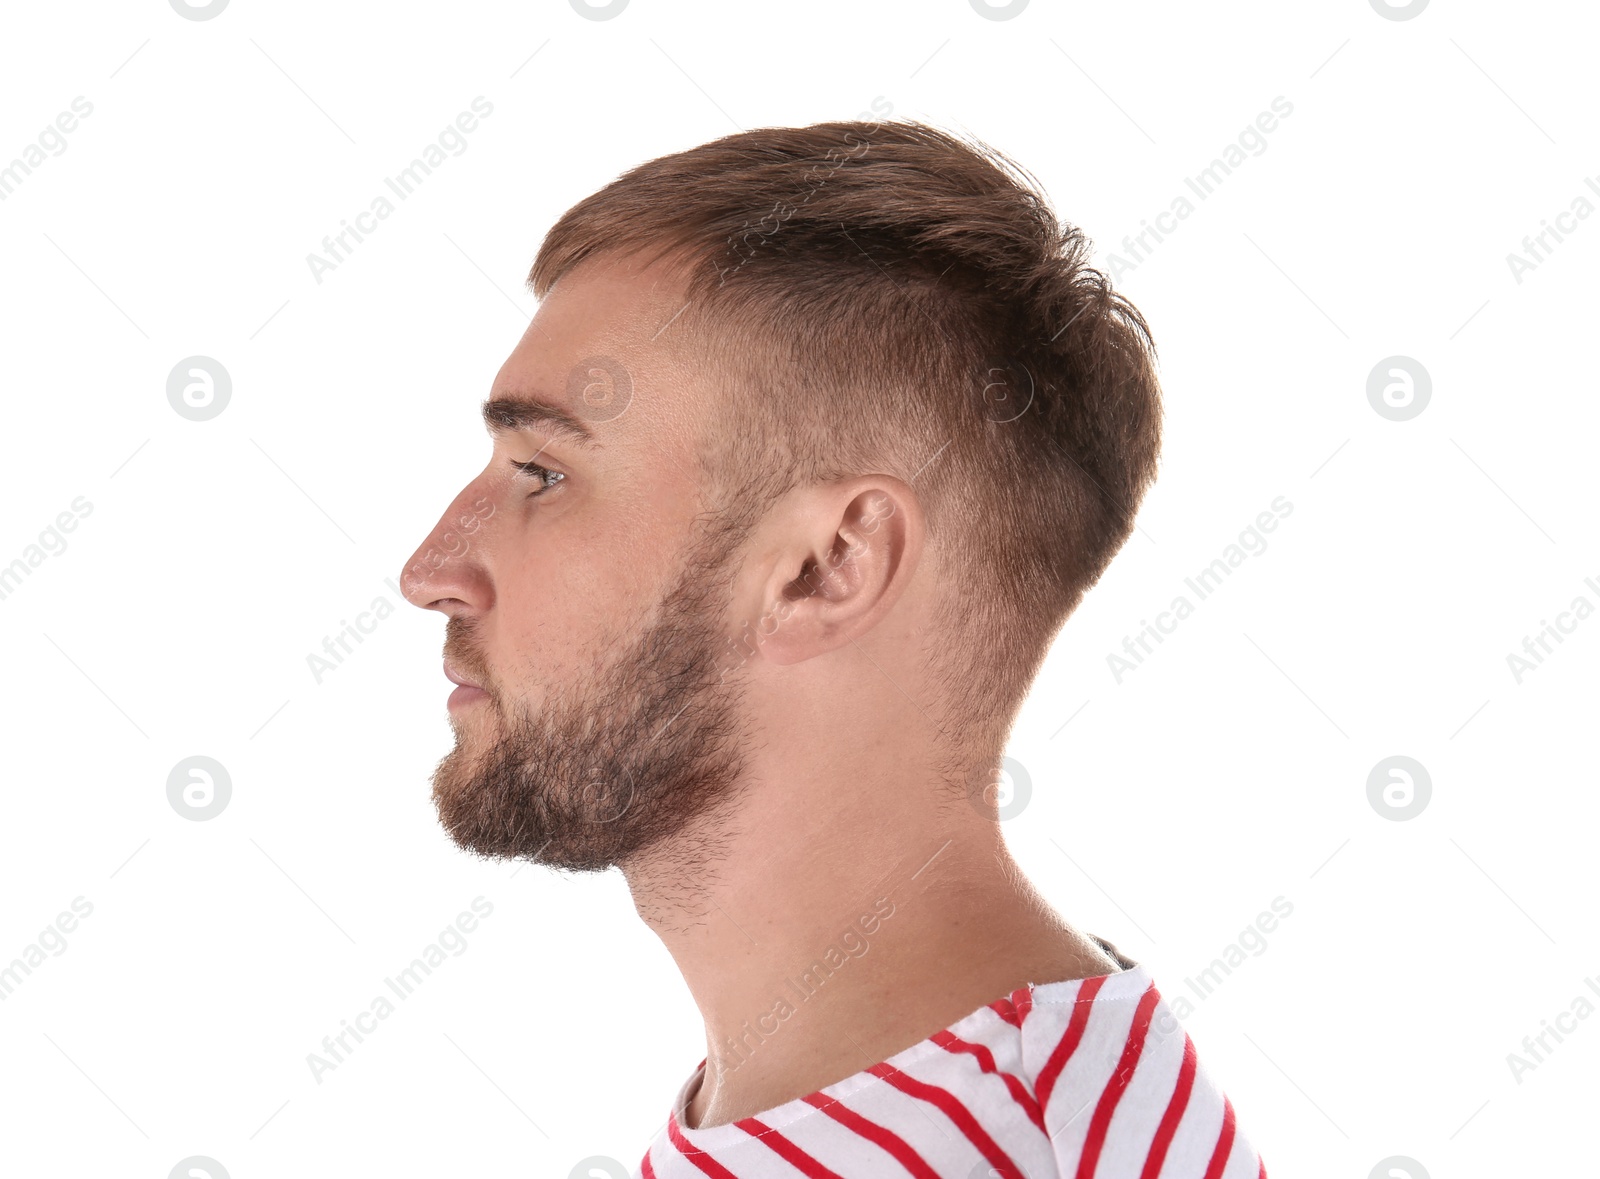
[403,122,1266,1179]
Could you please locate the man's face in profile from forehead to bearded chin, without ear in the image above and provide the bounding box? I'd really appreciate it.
[403,267,742,870]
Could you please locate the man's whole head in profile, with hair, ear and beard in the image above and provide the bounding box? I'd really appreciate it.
[403,123,1160,869]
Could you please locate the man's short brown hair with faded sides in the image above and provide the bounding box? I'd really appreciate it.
[528,120,1162,757]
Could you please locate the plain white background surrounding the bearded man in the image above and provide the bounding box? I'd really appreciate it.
[0,0,1600,1179]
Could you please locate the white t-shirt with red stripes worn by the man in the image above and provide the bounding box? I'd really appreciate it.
[635,947,1267,1179]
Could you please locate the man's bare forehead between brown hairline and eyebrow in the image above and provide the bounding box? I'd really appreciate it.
[490,258,709,446]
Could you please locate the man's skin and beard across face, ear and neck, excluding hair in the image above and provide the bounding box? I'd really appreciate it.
[402,256,1117,1128]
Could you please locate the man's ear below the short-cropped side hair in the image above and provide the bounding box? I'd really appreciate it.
[742,475,926,665]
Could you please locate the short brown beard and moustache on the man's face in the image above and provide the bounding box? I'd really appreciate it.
[434,518,746,872]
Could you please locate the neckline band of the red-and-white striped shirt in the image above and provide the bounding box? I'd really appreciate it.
[670,966,1150,1153]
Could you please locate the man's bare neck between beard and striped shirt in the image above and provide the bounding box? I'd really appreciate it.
[624,729,1115,1126]
